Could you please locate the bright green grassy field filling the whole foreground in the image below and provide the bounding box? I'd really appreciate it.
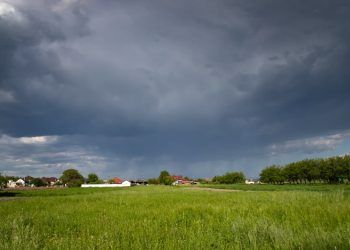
[0,185,350,249]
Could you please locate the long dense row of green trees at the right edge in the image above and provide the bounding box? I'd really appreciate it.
[260,155,350,184]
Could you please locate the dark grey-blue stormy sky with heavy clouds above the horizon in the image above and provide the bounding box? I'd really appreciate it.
[0,0,350,178]
